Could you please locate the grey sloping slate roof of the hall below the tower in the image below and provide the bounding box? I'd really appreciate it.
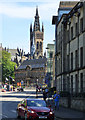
[17,58,47,70]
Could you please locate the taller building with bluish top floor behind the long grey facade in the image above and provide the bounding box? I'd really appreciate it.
[52,1,78,86]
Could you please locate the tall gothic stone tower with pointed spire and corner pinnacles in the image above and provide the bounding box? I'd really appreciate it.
[30,7,44,59]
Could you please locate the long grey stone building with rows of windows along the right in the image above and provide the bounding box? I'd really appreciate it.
[53,2,85,110]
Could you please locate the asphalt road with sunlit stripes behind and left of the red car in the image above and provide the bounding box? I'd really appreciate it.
[0,89,59,120]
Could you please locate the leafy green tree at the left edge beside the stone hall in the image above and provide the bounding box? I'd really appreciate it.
[2,50,16,82]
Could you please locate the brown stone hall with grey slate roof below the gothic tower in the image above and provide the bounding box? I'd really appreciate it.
[15,58,47,86]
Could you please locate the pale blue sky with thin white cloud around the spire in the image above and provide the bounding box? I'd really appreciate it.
[0,0,79,53]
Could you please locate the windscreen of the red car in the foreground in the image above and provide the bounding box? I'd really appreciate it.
[27,100,46,107]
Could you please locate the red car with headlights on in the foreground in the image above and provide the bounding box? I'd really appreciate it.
[17,98,54,120]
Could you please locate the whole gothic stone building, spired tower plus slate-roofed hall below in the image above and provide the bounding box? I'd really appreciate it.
[15,8,47,86]
